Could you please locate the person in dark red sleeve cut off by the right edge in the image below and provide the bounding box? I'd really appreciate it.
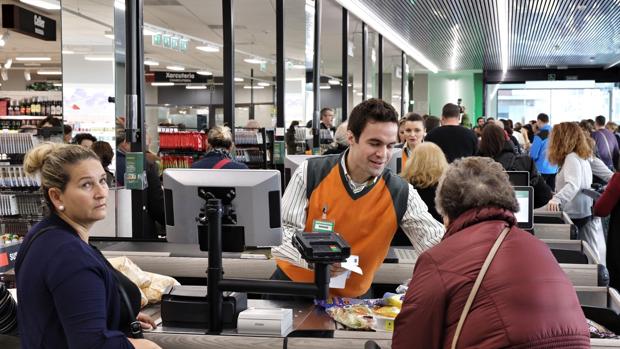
[594,172,620,290]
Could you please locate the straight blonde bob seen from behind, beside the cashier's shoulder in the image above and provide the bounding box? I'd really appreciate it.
[401,142,448,188]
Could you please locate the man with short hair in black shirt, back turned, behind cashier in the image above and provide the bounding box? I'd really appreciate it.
[425,103,478,163]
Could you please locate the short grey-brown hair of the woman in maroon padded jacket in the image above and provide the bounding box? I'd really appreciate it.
[435,157,519,221]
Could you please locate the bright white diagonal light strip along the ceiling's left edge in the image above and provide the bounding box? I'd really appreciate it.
[336,0,439,73]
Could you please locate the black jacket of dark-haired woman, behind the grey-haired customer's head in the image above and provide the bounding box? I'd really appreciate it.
[493,142,553,208]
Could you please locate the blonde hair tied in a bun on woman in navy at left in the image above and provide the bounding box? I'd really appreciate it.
[24,142,100,210]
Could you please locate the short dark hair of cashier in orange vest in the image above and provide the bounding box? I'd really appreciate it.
[347,98,398,141]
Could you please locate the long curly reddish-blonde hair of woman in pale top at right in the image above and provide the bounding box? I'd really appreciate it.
[547,122,592,166]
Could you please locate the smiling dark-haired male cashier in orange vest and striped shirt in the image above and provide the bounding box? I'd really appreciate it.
[272,98,443,297]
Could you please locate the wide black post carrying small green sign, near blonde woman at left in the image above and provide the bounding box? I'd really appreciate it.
[125,0,150,239]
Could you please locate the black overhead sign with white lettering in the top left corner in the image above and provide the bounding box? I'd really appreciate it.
[2,4,56,41]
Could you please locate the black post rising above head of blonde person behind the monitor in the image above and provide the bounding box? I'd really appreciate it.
[222,0,235,140]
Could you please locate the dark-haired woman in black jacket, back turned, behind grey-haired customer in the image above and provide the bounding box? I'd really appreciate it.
[478,125,552,208]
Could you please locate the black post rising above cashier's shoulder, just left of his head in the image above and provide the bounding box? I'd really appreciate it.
[312,0,322,151]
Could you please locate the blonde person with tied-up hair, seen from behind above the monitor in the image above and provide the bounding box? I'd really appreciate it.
[192,126,248,170]
